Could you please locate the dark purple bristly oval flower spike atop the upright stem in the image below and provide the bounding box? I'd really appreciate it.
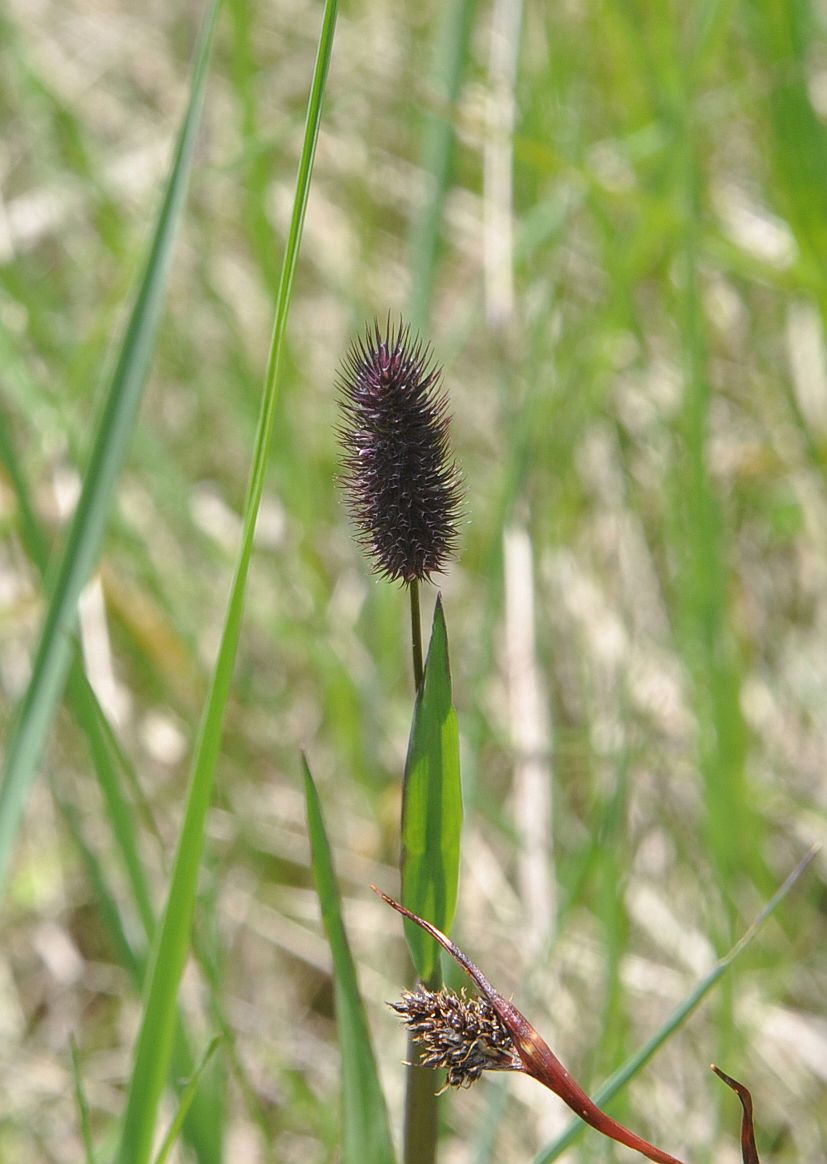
[337,320,462,582]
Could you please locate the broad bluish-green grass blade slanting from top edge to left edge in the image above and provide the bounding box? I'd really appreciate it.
[0,0,218,887]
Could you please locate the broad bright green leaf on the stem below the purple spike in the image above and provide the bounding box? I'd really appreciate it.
[402,598,462,981]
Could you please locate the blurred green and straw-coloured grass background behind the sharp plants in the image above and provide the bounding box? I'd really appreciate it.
[0,0,827,1164]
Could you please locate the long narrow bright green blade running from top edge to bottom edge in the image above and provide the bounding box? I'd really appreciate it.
[118,0,338,1164]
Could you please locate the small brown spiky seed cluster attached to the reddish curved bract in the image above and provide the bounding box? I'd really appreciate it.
[388,985,522,1091]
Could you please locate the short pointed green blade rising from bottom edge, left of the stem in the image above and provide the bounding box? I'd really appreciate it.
[303,760,395,1164]
